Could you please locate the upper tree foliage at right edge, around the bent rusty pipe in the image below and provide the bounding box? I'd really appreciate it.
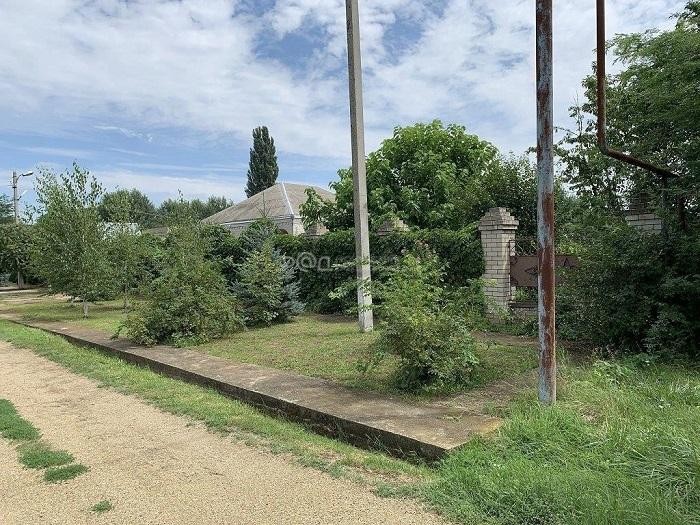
[559,0,700,222]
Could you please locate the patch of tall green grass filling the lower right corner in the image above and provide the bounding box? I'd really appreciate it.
[423,363,700,525]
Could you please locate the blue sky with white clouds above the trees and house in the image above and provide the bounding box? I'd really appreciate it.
[0,0,685,213]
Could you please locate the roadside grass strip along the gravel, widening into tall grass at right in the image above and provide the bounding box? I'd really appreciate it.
[0,322,700,525]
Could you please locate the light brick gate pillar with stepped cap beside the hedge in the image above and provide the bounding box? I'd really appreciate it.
[479,208,519,314]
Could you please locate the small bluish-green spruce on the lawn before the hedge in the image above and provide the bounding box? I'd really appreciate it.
[235,242,304,325]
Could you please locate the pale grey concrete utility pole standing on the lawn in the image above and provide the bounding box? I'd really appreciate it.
[345,0,374,332]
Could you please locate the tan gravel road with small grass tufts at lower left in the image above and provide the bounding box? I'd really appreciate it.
[0,342,442,525]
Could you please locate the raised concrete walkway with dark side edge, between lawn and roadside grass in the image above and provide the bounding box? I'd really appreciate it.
[5,316,516,459]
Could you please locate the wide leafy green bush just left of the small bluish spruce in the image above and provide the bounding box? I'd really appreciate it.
[120,213,243,346]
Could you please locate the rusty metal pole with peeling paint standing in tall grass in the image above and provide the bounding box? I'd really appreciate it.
[536,0,557,404]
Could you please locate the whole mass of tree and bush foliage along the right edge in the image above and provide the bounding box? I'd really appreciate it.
[560,1,700,356]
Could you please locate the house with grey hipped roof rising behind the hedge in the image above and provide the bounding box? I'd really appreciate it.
[204,182,335,235]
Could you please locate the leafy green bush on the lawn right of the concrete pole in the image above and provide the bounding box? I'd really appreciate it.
[370,246,478,391]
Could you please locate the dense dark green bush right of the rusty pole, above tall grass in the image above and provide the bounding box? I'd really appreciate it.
[559,221,700,357]
